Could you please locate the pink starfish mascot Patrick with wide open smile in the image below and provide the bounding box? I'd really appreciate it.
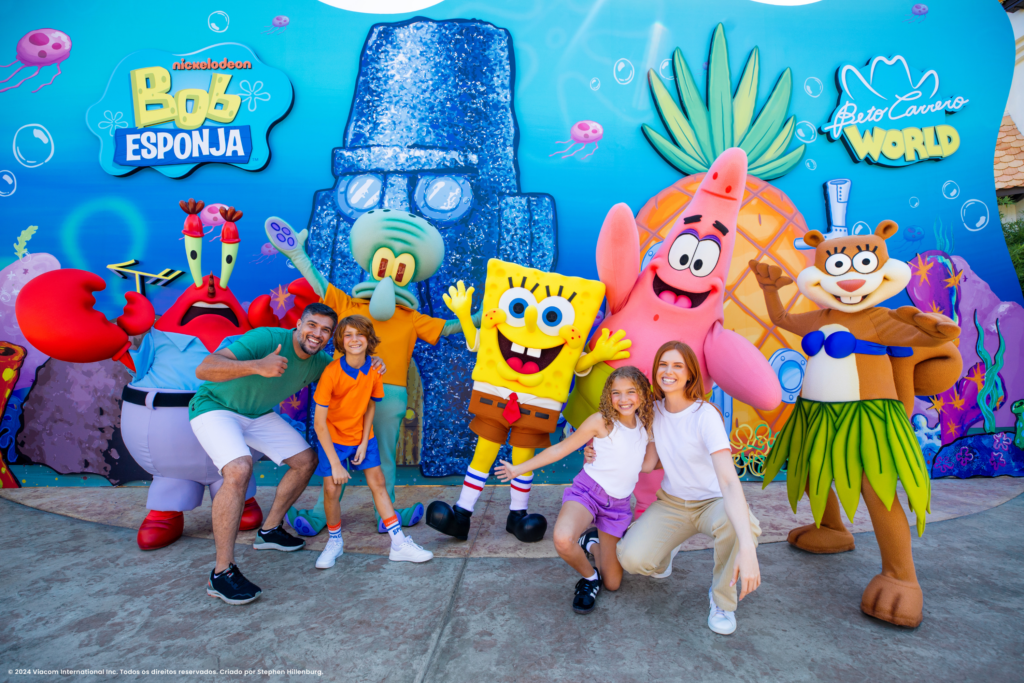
[564,147,782,517]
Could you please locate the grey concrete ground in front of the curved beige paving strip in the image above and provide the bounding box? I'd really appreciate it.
[0,497,1024,683]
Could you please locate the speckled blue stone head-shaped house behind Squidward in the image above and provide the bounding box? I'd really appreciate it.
[307,17,557,476]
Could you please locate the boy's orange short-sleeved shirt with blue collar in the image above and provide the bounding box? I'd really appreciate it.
[313,356,384,445]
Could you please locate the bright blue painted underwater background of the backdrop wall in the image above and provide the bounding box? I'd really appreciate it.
[0,0,1021,316]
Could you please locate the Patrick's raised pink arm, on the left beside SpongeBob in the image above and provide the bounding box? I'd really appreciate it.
[597,204,640,313]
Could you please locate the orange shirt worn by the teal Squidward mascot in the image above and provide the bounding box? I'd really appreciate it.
[324,285,444,387]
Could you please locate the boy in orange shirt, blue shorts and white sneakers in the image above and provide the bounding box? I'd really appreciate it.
[313,315,434,569]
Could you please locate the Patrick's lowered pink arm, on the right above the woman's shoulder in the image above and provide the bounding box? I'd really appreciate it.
[705,322,782,411]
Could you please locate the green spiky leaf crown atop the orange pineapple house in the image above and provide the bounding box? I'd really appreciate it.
[642,24,805,180]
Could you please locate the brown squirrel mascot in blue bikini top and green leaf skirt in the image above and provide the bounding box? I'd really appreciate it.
[750,220,963,627]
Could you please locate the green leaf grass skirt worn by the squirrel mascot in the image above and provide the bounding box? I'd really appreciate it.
[764,398,932,536]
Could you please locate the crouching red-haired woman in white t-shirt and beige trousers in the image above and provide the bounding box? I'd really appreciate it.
[598,341,761,635]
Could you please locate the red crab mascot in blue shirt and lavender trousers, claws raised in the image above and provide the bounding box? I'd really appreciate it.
[15,200,307,550]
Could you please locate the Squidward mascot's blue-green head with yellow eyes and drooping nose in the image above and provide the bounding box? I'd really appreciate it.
[349,209,444,322]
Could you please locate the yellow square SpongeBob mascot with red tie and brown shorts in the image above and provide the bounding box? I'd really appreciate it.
[427,259,631,543]
